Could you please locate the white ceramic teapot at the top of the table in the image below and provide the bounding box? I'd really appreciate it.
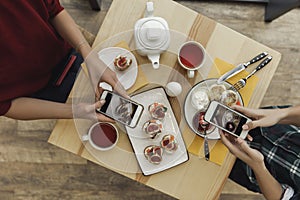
[134,2,170,69]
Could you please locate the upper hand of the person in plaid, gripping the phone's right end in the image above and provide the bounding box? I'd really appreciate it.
[232,105,282,130]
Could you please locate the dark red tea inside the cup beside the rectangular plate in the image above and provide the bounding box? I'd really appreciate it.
[91,124,117,148]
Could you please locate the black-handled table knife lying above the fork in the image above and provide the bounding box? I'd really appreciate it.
[217,52,268,84]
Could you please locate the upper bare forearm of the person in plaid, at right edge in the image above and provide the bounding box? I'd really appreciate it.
[279,105,300,126]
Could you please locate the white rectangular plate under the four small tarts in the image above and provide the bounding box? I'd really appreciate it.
[126,88,188,175]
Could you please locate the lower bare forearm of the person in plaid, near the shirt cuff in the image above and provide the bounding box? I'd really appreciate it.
[252,164,283,200]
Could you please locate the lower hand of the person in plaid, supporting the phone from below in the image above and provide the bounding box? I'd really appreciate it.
[220,132,264,169]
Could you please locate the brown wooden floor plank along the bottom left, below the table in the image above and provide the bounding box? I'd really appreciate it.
[0,162,173,200]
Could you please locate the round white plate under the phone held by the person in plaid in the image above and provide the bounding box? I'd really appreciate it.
[183,78,244,139]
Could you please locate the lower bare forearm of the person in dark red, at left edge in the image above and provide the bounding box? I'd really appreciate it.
[5,97,73,120]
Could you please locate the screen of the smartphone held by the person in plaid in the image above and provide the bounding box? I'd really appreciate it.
[211,104,248,136]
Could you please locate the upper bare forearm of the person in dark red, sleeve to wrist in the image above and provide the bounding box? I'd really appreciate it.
[52,10,91,58]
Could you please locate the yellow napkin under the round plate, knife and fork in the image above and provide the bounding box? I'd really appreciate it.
[188,58,258,165]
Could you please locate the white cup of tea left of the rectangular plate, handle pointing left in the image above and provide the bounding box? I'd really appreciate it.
[81,122,119,151]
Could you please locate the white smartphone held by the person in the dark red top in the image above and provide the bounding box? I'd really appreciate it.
[97,90,144,128]
